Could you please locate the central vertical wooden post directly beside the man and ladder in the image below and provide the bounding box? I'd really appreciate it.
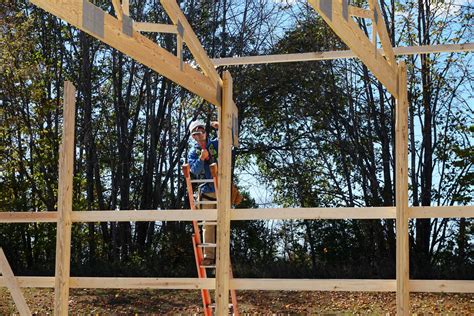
[216,71,233,315]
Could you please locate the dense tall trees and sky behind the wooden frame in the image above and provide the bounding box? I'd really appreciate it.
[0,0,474,279]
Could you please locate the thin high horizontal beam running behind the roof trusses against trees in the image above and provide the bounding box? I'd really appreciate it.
[212,43,474,67]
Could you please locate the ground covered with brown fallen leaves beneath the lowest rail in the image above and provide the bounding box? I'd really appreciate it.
[0,288,474,315]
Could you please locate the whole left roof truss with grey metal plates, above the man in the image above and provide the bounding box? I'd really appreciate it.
[31,0,222,106]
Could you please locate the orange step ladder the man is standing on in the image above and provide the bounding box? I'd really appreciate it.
[182,163,239,316]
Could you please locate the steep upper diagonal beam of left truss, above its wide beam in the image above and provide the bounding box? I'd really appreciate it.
[161,0,222,87]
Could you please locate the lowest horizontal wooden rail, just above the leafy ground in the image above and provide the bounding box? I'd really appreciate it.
[0,276,474,293]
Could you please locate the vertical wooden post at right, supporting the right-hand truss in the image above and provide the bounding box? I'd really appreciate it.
[395,62,410,315]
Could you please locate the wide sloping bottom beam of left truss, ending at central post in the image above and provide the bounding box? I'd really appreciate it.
[31,0,221,106]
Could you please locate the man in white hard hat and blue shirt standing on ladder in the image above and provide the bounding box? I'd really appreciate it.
[188,120,219,266]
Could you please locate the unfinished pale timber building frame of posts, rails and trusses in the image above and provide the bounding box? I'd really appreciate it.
[0,0,474,315]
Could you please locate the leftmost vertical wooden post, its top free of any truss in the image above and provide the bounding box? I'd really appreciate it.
[54,81,76,315]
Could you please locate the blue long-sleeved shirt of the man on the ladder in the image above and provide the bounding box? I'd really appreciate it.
[188,139,219,193]
